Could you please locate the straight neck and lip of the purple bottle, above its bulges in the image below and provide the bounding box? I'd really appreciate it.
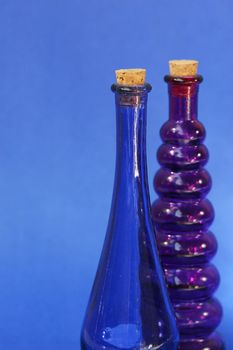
[164,75,203,121]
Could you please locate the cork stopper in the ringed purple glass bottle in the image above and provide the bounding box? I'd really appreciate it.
[169,60,198,77]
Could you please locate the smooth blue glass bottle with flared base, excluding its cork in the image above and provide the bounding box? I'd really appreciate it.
[81,72,178,350]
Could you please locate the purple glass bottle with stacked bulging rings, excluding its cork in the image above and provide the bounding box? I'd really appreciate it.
[152,61,223,350]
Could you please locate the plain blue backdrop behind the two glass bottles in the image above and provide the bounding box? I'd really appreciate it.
[0,0,233,350]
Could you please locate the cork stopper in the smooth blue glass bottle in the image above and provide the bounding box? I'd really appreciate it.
[115,68,146,86]
